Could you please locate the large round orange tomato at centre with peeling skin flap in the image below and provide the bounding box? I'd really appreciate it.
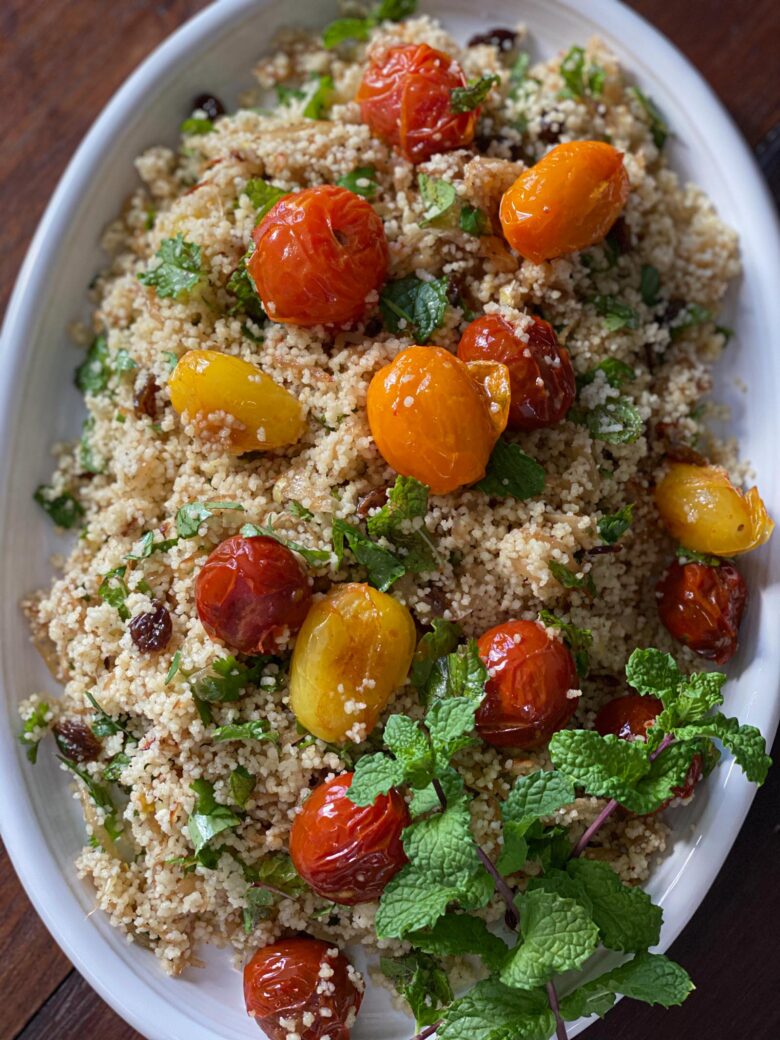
[367,346,510,495]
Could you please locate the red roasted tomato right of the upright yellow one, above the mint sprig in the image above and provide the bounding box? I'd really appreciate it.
[476,621,579,748]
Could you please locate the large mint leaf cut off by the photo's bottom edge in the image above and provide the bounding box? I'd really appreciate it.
[436,979,555,1040]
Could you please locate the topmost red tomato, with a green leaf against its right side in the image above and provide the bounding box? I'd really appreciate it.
[356,44,479,162]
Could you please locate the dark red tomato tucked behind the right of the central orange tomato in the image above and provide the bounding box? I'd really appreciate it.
[458,314,576,430]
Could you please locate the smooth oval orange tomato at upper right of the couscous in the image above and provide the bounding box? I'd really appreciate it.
[499,140,628,263]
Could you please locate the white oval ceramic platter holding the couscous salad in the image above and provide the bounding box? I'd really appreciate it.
[0,0,780,1040]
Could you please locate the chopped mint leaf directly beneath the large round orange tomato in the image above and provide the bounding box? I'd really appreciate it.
[366,476,439,574]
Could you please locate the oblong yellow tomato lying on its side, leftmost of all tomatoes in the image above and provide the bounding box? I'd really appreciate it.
[168,350,306,454]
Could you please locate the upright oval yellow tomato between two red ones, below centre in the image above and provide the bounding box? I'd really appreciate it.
[290,582,417,744]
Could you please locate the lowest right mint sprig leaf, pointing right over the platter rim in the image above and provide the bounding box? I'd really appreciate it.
[561,954,694,1021]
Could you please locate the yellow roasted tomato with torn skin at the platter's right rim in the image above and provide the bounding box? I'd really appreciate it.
[655,462,775,556]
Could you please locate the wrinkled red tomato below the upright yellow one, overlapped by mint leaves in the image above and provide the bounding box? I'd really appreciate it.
[290,773,410,906]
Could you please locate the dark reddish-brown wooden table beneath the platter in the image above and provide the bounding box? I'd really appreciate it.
[0,0,780,1040]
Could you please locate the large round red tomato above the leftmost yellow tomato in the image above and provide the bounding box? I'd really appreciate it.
[246,184,388,326]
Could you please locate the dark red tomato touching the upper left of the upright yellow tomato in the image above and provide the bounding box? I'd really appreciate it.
[196,535,311,653]
